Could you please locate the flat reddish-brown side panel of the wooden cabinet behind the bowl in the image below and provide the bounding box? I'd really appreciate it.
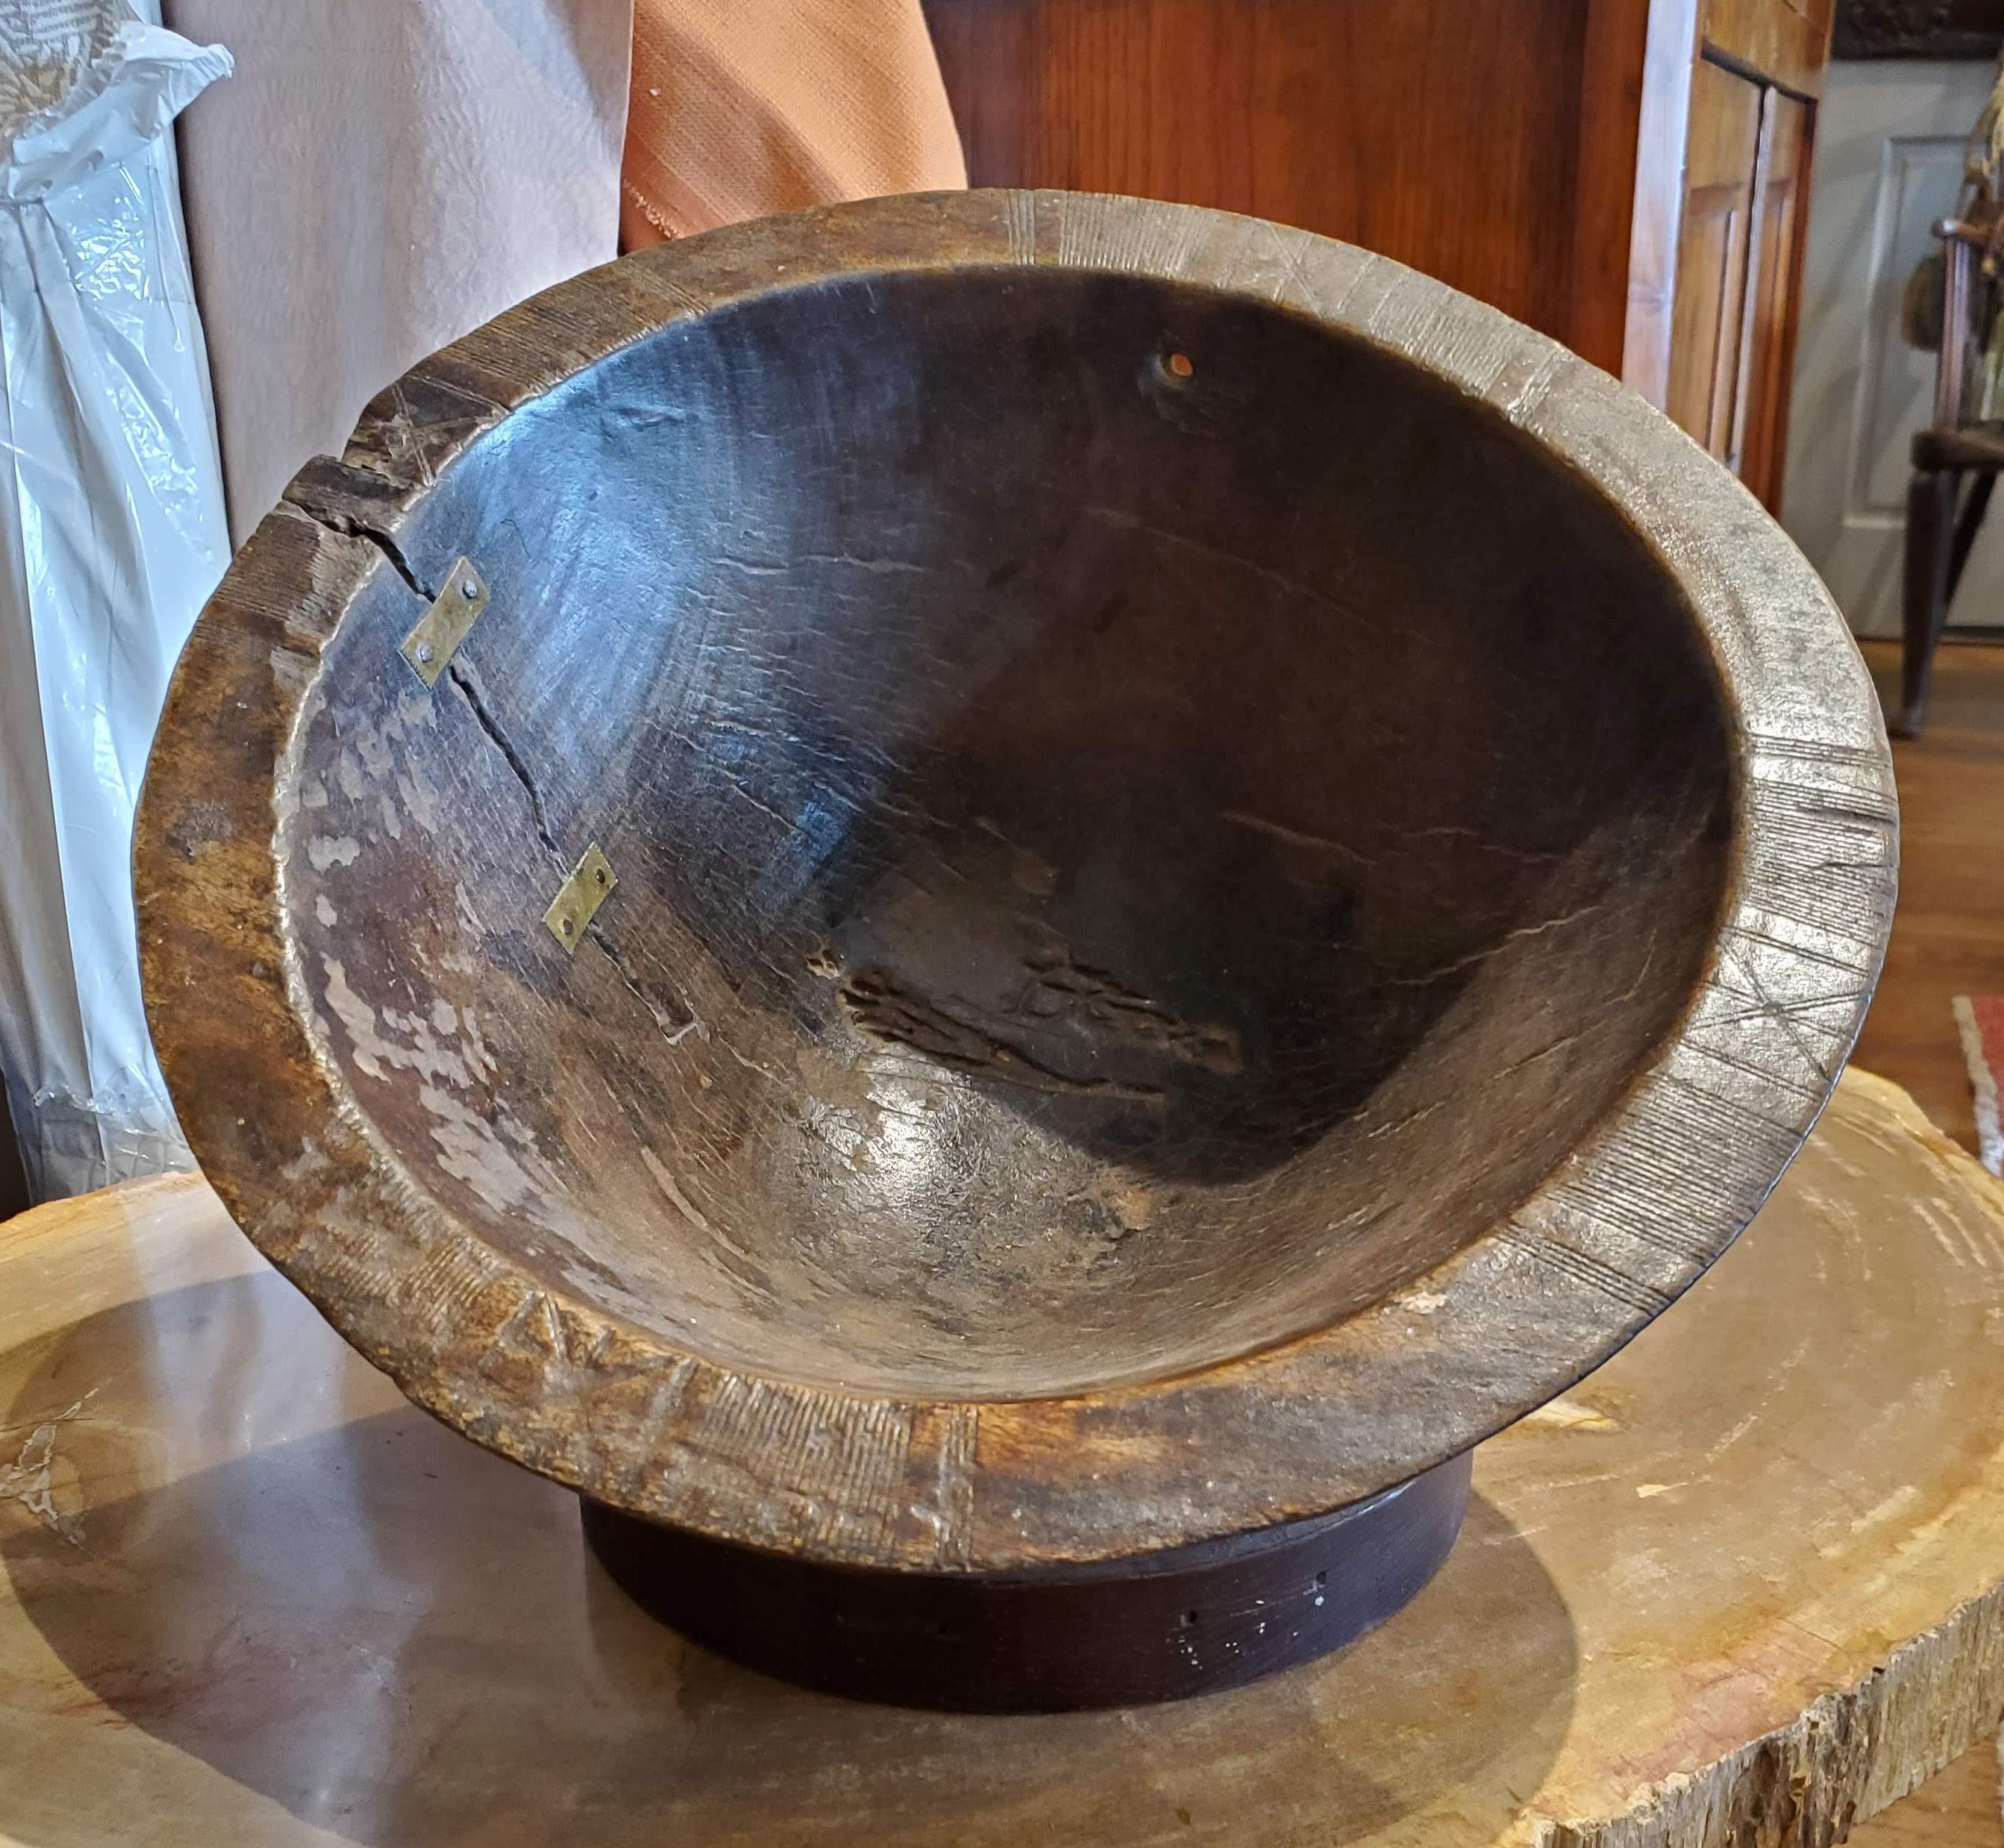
[928,0,1591,356]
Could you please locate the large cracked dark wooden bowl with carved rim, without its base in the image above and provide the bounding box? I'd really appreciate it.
[137,192,1896,1707]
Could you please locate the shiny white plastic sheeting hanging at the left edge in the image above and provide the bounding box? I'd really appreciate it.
[0,0,231,1199]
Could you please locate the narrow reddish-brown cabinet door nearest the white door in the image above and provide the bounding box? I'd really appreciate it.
[1737,90,1812,513]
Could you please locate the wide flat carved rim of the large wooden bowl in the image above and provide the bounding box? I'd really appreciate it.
[134,190,1898,1573]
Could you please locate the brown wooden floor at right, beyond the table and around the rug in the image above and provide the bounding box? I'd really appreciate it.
[1852,643,2004,1848]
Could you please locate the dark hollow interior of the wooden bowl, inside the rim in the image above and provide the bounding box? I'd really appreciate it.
[278,269,1734,1399]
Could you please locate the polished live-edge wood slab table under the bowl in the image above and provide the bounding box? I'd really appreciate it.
[0,1073,2004,1848]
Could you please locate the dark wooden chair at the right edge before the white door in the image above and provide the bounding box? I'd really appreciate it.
[1892,219,2004,738]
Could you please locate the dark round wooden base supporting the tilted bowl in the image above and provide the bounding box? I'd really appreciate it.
[583,1455,1471,1714]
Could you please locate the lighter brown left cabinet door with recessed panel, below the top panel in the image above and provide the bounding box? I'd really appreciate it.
[1663,58,1764,461]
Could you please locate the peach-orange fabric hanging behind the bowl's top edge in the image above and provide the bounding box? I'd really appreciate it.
[619,0,968,249]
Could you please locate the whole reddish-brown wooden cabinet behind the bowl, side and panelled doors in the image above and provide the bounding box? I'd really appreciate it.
[926,0,1830,505]
